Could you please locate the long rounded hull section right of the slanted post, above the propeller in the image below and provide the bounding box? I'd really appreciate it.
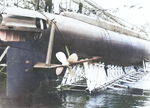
[45,13,150,65]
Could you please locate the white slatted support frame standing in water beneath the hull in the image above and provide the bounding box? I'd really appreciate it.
[59,62,145,93]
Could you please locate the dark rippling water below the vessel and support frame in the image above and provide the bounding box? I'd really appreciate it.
[0,75,150,108]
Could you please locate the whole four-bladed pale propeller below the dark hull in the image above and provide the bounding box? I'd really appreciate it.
[56,52,78,76]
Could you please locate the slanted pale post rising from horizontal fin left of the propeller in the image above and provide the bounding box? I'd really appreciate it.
[46,21,55,65]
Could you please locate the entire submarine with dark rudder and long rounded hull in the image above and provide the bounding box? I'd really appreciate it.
[0,7,150,98]
